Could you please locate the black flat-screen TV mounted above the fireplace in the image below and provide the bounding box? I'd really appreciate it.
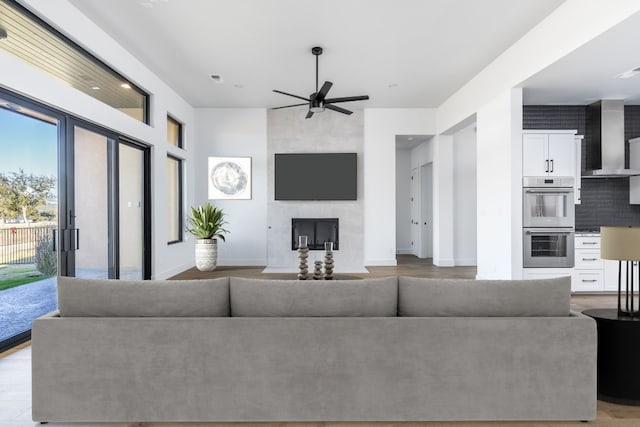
[274,153,358,200]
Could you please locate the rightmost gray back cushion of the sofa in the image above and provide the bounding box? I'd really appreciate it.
[398,277,571,317]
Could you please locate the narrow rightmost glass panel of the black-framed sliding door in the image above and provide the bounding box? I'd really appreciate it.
[118,143,144,280]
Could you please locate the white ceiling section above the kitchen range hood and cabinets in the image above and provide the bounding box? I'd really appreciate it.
[522,9,640,105]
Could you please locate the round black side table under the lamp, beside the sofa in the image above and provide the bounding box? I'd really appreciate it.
[582,308,640,405]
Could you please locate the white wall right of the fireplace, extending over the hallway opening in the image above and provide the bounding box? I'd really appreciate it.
[364,108,436,265]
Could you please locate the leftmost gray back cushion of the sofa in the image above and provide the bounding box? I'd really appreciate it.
[58,277,229,317]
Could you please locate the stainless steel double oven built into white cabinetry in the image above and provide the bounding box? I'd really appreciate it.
[522,177,575,268]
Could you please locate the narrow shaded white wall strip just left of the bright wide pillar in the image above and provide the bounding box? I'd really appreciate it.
[453,123,477,265]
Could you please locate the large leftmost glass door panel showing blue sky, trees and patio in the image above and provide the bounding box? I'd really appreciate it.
[0,93,62,352]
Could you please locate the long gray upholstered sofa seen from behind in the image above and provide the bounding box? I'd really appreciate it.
[32,277,596,422]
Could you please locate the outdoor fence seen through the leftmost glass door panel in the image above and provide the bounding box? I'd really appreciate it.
[0,225,55,264]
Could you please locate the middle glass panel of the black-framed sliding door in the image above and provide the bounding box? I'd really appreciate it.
[73,126,110,279]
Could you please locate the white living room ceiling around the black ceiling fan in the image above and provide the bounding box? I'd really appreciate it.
[70,0,562,108]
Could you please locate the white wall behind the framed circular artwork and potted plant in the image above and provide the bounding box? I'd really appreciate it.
[194,108,267,265]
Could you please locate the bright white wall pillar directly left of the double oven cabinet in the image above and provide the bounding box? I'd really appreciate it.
[477,89,522,279]
